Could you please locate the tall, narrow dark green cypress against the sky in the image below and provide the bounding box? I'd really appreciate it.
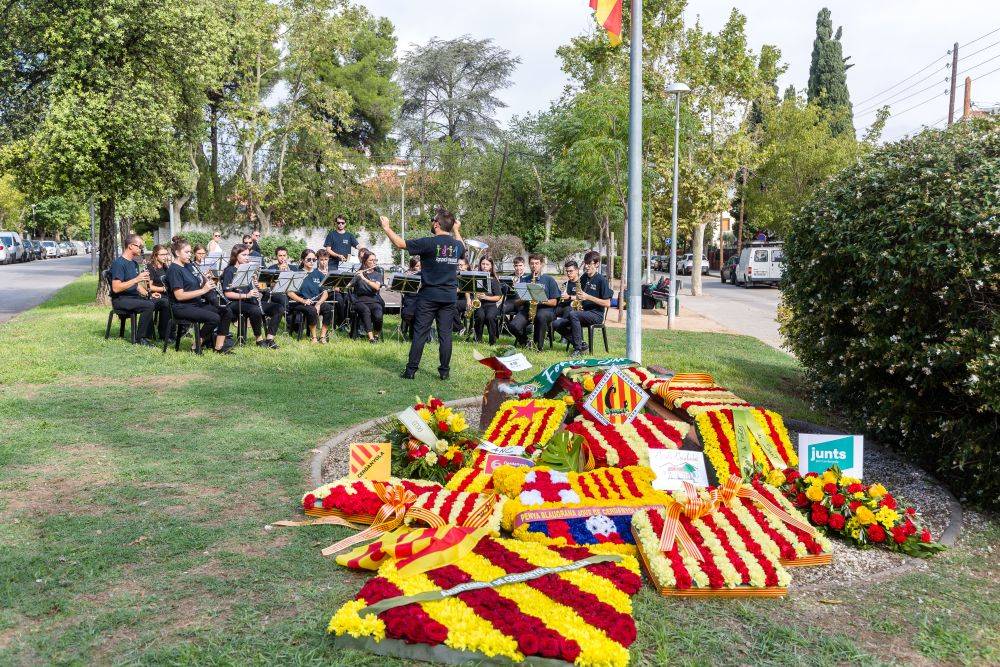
[806,7,854,134]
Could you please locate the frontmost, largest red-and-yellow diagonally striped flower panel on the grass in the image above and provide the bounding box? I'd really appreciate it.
[327,538,642,666]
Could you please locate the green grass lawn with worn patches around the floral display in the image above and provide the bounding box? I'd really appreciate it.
[0,277,1000,665]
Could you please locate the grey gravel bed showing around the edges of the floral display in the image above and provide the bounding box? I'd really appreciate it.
[323,406,951,590]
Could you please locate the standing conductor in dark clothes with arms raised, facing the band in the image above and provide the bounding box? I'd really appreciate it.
[379,209,465,380]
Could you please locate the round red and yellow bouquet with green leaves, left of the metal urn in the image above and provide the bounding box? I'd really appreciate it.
[384,396,479,484]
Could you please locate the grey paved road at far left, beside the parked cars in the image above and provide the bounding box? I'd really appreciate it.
[0,255,90,323]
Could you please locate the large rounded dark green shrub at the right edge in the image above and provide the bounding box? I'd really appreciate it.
[783,119,1000,507]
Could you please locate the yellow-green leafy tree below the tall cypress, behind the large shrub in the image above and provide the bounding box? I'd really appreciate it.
[746,98,860,236]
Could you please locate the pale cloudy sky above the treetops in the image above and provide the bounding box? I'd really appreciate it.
[363,0,1000,139]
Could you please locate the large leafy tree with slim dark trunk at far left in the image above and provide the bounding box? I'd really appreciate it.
[0,0,228,301]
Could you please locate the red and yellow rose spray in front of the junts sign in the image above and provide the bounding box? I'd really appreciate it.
[767,466,944,558]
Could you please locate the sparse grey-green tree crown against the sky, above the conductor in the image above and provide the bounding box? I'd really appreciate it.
[400,35,521,152]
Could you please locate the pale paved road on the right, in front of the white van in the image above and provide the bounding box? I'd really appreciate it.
[660,275,782,349]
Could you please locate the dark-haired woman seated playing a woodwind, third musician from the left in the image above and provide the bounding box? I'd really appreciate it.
[167,238,233,354]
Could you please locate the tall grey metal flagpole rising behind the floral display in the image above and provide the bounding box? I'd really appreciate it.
[625,0,642,363]
